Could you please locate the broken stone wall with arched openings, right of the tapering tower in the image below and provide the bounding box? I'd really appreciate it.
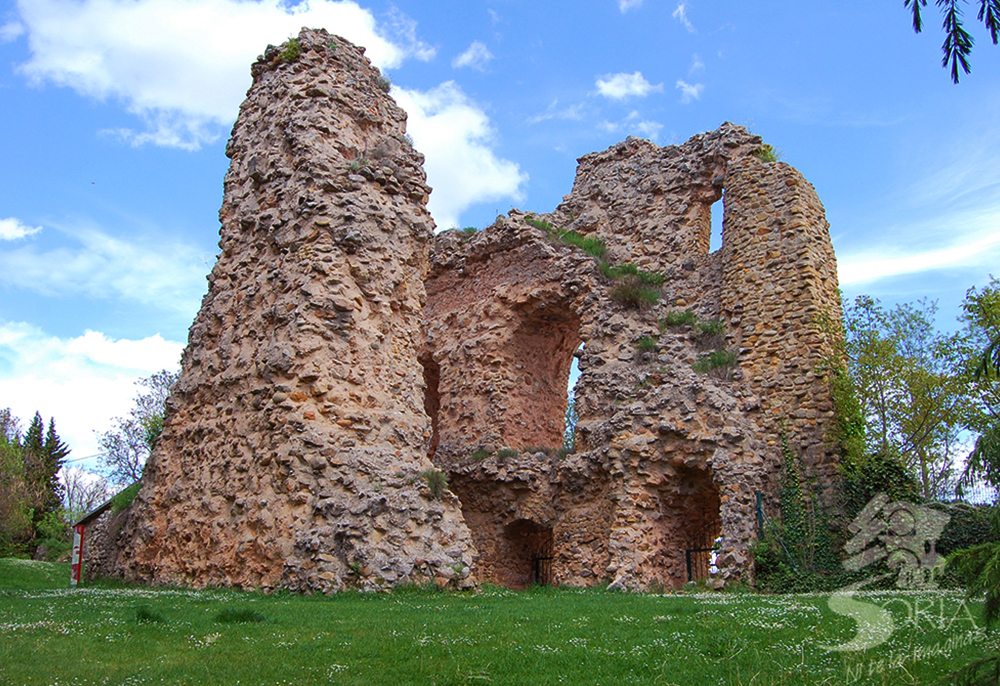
[421,124,839,588]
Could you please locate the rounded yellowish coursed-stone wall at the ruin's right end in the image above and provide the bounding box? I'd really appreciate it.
[719,160,840,486]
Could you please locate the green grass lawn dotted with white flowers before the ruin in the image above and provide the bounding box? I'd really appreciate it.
[0,560,998,686]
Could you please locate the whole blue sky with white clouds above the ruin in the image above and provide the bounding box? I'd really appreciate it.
[0,0,1000,468]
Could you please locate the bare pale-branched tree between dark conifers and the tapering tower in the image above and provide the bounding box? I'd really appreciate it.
[97,369,180,487]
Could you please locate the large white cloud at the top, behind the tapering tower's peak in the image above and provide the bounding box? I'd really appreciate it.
[12,0,426,148]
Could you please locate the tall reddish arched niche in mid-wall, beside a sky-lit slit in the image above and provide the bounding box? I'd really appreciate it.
[504,302,580,449]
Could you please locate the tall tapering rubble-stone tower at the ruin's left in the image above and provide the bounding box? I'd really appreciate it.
[108,29,475,591]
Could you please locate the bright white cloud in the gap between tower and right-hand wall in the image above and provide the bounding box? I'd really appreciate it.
[392,81,528,229]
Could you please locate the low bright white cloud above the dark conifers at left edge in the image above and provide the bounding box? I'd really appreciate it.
[0,321,184,459]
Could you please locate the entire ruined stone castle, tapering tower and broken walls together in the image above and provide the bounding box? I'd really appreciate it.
[91,30,840,591]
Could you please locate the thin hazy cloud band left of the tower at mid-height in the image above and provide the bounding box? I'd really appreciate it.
[0,224,214,314]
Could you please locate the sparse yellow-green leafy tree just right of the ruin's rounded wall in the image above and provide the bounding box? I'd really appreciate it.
[844,296,971,498]
